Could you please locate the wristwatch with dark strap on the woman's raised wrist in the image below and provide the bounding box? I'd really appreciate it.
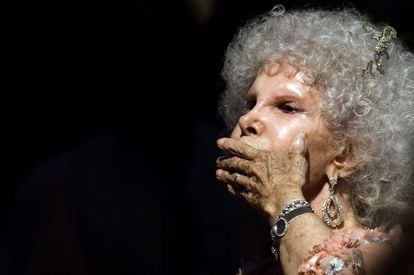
[270,200,314,258]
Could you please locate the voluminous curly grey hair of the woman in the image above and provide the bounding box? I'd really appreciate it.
[219,8,414,227]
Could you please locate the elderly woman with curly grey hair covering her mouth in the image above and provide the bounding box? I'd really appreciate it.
[216,6,414,274]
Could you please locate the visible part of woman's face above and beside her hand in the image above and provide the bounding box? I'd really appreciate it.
[231,63,337,188]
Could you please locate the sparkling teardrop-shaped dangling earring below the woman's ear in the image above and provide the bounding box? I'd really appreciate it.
[322,176,344,228]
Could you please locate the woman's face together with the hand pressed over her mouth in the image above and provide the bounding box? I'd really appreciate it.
[216,63,341,222]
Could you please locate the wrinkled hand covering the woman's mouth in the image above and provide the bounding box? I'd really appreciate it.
[217,133,308,221]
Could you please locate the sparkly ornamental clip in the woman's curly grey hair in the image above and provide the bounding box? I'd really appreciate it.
[362,26,397,78]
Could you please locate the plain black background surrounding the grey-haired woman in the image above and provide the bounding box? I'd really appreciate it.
[0,0,414,274]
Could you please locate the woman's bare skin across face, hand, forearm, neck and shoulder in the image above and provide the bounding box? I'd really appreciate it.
[216,59,402,274]
